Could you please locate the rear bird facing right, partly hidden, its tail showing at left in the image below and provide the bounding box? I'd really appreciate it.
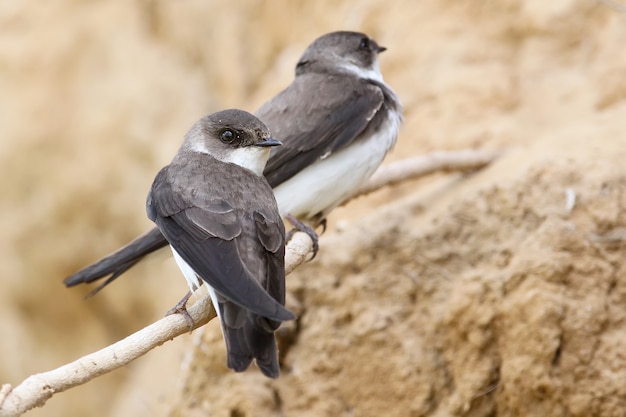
[64,31,402,292]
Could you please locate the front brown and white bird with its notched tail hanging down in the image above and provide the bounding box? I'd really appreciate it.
[146,110,295,378]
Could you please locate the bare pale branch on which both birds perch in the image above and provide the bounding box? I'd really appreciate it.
[0,150,498,417]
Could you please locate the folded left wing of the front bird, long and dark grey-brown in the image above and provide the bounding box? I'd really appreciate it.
[148,182,295,321]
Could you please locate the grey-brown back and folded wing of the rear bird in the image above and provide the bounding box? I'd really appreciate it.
[255,73,384,188]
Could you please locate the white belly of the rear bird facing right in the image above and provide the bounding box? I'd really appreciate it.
[274,115,400,219]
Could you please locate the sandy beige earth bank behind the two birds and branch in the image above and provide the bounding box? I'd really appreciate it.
[0,0,626,417]
